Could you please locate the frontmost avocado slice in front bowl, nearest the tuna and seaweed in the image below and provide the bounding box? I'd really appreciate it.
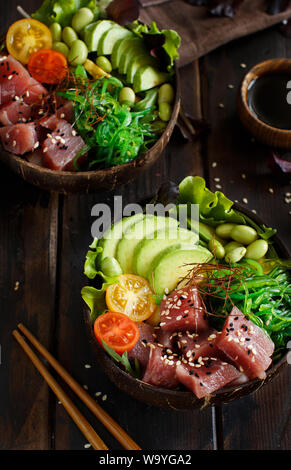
[148,244,212,295]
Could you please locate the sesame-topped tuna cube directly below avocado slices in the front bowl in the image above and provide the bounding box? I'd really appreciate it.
[160,287,209,333]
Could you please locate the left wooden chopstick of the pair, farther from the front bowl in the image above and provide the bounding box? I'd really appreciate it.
[12,330,108,450]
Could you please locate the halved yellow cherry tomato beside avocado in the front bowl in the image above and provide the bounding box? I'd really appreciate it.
[106,274,156,322]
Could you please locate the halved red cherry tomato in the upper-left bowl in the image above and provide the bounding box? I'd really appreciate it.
[27,49,68,85]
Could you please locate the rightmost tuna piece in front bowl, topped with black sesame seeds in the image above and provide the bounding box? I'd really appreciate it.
[216,307,274,379]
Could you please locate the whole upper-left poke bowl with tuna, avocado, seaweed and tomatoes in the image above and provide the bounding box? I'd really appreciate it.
[0,1,180,193]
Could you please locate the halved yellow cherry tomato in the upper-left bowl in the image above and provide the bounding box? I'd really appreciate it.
[6,18,53,64]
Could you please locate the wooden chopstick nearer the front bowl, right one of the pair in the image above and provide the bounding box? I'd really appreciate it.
[18,323,141,450]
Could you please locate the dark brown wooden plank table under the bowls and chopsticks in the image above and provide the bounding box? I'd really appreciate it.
[0,0,291,450]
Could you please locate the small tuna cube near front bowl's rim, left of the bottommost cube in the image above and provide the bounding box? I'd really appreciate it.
[142,345,179,389]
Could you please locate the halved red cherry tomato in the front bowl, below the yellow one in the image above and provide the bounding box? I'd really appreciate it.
[94,312,139,354]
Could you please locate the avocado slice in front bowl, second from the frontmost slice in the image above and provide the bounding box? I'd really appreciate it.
[133,227,199,278]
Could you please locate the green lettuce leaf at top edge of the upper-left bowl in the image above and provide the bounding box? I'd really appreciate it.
[31,0,100,27]
